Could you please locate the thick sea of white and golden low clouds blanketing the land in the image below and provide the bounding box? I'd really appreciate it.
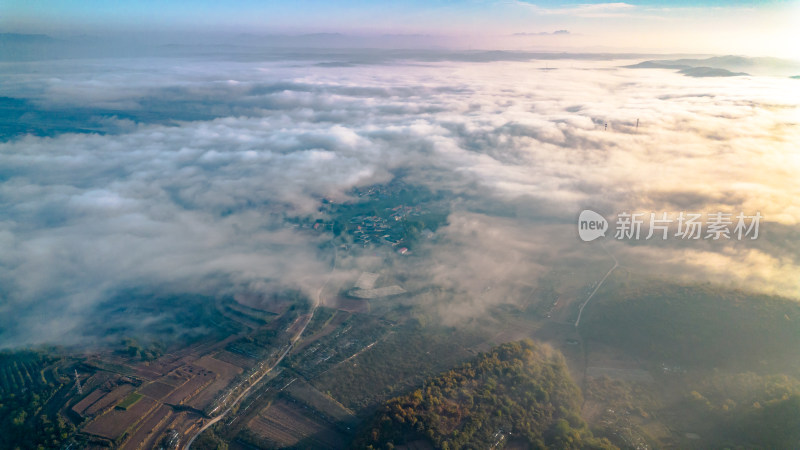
[0,51,800,347]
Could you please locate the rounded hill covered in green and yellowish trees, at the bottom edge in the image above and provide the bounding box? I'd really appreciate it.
[354,340,615,449]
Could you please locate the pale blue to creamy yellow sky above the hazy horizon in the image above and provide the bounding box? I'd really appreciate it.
[0,0,800,58]
